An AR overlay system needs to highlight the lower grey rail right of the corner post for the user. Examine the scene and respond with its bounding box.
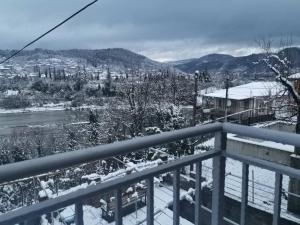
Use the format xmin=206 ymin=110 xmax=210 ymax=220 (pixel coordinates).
xmin=224 ymin=152 xmax=300 ymax=180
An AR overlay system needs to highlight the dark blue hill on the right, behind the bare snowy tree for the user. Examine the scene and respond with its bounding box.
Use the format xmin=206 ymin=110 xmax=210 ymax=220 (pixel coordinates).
xmin=170 ymin=48 xmax=300 ymax=77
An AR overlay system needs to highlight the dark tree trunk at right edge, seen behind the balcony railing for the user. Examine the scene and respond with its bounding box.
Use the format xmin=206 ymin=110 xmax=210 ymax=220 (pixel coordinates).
xmin=288 ymin=106 xmax=300 ymax=215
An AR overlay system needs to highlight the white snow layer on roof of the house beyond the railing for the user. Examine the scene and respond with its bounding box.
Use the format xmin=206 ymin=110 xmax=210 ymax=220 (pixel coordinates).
xmin=204 ymin=81 xmax=283 ymax=100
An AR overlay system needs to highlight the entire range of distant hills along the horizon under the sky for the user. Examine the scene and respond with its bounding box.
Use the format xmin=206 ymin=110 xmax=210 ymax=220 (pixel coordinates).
xmin=0 ymin=48 xmax=300 ymax=78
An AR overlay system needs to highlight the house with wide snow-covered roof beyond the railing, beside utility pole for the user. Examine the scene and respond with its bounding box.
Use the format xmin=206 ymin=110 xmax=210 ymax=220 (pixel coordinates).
xmin=203 ymin=81 xmax=284 ymax=123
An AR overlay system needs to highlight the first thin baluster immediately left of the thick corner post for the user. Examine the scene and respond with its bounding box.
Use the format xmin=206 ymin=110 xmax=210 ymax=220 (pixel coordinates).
xmin=195 ymin=162 xmax=203 ymax=225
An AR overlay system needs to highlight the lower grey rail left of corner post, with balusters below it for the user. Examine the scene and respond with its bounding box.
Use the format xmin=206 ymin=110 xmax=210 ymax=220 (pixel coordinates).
xmin=0 ymin=150 xmax=221 ymax=225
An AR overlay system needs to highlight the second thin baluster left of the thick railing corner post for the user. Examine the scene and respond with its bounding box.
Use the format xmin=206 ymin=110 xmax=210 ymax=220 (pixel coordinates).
xmin=173 ymin=169 xmax=180 ymax=225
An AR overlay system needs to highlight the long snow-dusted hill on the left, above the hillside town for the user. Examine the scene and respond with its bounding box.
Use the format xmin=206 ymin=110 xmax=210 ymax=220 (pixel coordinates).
xmin=0 ymin=48 xmax=164 ymax=69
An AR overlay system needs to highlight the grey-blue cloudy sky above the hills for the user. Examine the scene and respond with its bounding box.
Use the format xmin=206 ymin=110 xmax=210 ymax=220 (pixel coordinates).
xmin=0 ymin=0 xmax=300 ymax=61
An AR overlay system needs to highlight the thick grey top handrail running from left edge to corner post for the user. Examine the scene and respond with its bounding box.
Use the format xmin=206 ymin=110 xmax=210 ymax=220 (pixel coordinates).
xmin=0 ymin=123 xmax=222 ymax=183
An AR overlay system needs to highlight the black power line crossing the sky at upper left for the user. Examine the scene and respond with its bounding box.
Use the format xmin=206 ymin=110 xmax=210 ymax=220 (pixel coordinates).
xmin=0 ymin=0 xmax=98 ymax=65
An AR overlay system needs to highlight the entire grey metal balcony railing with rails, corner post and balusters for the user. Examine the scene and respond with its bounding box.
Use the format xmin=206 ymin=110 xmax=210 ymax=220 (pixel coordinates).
xmin=0 ymin=123 xmax=300 ymax=225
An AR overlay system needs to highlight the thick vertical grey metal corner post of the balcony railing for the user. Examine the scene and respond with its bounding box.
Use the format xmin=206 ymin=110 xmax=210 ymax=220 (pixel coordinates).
xmin=211 ymin=131 xmax=227 ymax=225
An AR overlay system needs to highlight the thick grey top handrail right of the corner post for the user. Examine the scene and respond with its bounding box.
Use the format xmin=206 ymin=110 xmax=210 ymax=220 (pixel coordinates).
xmin=223 ymin=123 xmax=300 ymax=147
